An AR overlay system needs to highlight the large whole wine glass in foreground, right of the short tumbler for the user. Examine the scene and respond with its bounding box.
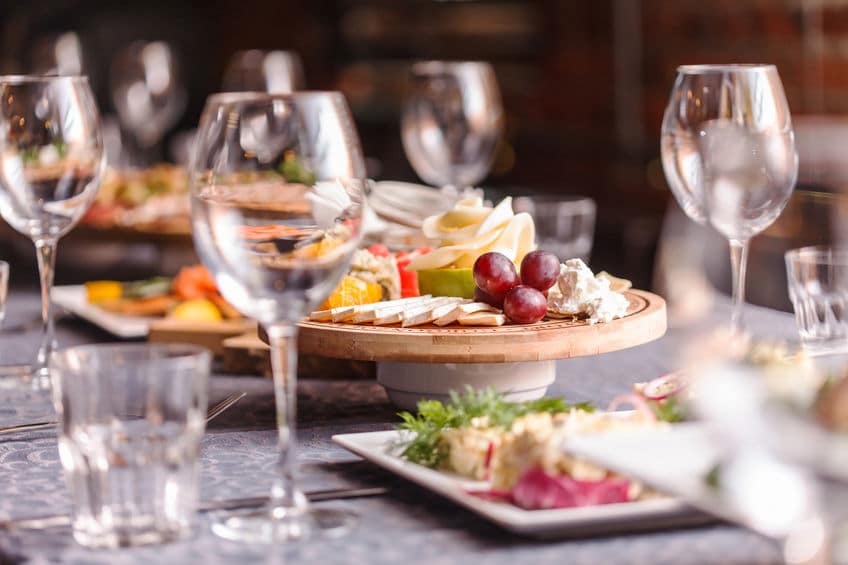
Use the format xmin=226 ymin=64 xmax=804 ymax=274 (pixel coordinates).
xmin=190 ymin=92 xmax=366 ymax=542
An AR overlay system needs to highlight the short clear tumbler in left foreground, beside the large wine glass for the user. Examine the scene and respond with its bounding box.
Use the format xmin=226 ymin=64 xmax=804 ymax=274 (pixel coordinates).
xmin=50 ymin=344 xmax=211 ymax=548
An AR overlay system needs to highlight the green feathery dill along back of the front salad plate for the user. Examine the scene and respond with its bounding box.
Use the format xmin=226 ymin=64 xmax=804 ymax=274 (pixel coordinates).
xmin=398 ymin=388 xmax=594 ymax=468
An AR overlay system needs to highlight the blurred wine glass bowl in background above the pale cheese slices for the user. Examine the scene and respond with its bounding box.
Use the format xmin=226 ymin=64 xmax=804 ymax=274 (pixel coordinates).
xmin=401 ymin=61 xmax=503 ymax=189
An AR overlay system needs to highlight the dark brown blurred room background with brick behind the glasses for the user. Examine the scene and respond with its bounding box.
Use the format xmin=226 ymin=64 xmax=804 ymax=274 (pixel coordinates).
xmin=0 ymin=0 xmax=848 ymax=304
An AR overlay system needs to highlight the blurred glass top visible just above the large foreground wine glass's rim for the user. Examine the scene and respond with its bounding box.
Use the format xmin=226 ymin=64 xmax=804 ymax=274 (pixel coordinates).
xmin=224 ymin=49 xmax=305 ymax=94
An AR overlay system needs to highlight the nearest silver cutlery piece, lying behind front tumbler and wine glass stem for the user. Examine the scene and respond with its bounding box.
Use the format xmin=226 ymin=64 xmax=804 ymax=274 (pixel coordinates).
xmin=0 ymin=487 xmax=389 ymax=530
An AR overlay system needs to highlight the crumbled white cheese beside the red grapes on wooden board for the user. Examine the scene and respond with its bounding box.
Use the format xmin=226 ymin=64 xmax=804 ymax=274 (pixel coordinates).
xmin=548 ymin=259 xmax=628 ymax=324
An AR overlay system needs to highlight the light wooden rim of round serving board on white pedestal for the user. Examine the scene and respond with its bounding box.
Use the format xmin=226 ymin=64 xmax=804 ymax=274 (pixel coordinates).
xmin=298 ymin=290 xmax=666 ymax=363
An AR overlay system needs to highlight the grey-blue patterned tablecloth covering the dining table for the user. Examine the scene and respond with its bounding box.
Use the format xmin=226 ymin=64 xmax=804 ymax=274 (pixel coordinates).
xmin=0 ymin=291 xmax=796 ymax=565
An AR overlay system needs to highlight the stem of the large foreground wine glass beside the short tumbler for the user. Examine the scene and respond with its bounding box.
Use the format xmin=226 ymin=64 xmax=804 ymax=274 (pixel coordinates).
xmin=267 ymin=323 xmax=302 ymax=519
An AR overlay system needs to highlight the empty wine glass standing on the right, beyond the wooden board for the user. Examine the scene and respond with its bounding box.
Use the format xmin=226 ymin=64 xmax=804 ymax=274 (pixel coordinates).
xmin=661 ymin=65 xmax=798 ymax=334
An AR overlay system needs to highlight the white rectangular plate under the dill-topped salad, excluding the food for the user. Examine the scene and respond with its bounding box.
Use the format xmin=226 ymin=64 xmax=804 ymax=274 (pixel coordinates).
xmin=333 ymin=431 xmax=712 ymax=538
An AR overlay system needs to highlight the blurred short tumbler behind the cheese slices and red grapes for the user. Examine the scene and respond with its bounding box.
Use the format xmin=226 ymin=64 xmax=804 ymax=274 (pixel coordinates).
xmin=512 ymin=195 xmax=597 ymax=262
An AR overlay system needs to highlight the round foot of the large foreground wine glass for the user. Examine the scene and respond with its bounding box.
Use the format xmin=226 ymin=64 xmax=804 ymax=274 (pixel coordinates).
xmin=212 ymin=508 xmax=359 ymax=544
